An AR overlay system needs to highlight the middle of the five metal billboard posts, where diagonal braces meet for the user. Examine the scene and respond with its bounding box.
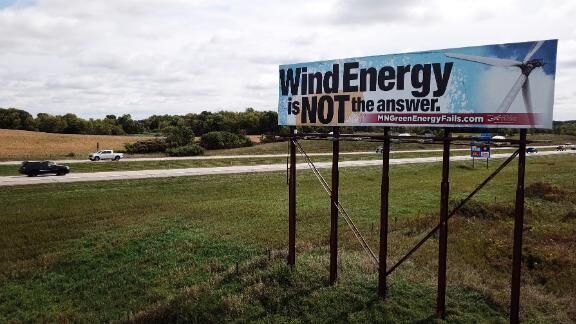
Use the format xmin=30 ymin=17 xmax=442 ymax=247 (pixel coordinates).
xmin=378 ymin=127 xmax=390 ymax=298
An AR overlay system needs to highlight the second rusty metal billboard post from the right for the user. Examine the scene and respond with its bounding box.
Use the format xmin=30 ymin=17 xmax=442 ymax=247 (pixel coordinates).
xmin=436 ymin=128 xmax=450 ymax=318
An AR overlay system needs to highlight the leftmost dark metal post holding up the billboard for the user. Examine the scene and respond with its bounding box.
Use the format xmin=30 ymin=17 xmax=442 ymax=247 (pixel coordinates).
xmin=288 ymin=126 xmax=296 ymax=267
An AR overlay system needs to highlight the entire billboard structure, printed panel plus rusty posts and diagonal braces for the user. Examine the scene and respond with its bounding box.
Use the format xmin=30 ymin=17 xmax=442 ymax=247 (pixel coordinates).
xmin=278 ymin=39 xmax=558 ymax=323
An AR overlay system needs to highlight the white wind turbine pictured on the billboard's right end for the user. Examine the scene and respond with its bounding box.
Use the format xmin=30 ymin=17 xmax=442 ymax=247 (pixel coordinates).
xmin=445 ymin=41 xmax=544 ymax=126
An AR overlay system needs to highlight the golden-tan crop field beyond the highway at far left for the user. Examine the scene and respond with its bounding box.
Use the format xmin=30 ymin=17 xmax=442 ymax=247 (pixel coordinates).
xmin=0 ymin=129 xmax=153 ymax=161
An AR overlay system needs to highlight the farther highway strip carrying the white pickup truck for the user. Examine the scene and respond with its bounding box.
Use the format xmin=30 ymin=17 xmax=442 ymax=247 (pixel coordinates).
xmin=0 ymin=146 xmax=556 ymax=165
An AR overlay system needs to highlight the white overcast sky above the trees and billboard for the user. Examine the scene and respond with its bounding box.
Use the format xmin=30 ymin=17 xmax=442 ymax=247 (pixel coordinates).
xmin=0 ymin=0 xmax=576 ymax=120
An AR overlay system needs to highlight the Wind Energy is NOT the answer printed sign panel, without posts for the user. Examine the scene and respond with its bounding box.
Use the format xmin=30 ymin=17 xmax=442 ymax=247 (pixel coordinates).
xmin=278 ymin=40 xmax=558 ymax=128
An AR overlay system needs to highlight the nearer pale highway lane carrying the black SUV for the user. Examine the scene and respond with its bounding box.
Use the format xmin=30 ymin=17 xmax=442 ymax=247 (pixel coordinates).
xmin=0 ymin=150 xmax=576 ymax=186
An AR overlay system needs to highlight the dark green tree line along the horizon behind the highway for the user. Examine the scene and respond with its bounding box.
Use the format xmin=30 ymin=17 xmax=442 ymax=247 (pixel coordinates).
xmin=0 ymin=108 xmax=576 ymax=136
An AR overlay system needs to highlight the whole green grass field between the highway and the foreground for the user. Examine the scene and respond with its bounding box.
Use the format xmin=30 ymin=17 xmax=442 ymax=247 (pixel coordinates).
xmin=0 ymin=156 xmax=576 ymax=323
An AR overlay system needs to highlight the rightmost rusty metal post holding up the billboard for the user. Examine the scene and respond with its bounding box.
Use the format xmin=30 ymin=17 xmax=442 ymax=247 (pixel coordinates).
xmin=510 ymin=129 xmax=526 ymax=323
